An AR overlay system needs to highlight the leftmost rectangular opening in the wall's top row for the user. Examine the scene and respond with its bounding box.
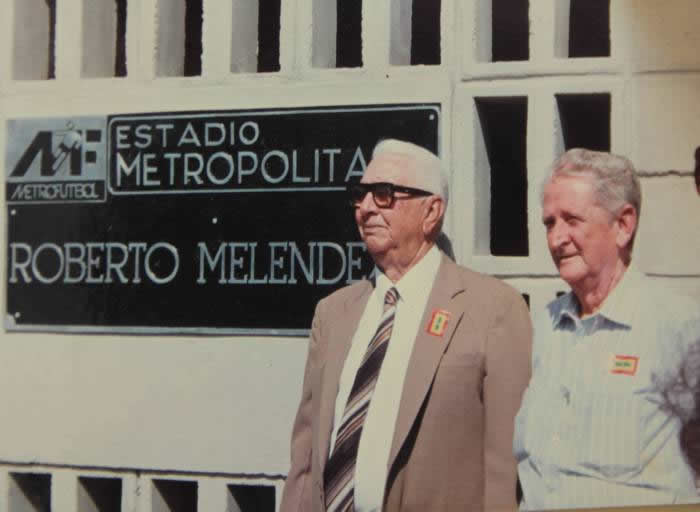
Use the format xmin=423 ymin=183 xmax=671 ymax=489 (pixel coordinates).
xmin=12 ymin=0 xmax=56 ymax=80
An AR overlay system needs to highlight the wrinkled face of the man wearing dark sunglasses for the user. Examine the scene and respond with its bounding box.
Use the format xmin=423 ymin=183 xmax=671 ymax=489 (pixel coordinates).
xmin=355 ymin=153 xmax=432 ymax=263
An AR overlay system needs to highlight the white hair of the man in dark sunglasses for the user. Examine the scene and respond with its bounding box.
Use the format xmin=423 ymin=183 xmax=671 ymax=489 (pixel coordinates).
xmin=372 ymin=139 xmax=450 ymax=205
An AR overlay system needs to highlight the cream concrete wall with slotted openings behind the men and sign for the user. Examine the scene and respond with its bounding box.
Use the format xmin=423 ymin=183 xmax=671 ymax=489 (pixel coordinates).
xmin=0 ymin=0 xmax=700 ymax=512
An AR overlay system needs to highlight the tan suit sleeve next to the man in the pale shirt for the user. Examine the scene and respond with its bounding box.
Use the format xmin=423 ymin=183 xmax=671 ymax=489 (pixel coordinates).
xmin=483 ymin=294 xmax=532 ymax=512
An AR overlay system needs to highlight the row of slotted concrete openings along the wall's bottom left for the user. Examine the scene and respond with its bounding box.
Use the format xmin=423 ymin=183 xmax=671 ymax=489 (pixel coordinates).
xmin=0 ymin=464 xmax=284 ymax=512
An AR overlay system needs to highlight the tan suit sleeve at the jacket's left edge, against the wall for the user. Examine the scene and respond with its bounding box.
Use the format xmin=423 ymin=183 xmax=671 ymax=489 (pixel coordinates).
xmin=280 ymin=303 xmax=321 ymax=512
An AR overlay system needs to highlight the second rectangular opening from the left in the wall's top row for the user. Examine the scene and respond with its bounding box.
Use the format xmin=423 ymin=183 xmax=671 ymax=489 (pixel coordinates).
xmin=81 ymin=0 xmax=127 ymax=78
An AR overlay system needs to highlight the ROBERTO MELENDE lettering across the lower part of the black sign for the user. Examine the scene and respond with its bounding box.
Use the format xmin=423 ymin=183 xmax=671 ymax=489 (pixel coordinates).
xmin=9 ymin=241 xmax=371 ymax=286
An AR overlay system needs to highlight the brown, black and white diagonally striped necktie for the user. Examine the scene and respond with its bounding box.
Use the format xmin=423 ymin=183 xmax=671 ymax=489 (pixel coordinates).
xmin=323 ymin=287 xmax=399 ymax=512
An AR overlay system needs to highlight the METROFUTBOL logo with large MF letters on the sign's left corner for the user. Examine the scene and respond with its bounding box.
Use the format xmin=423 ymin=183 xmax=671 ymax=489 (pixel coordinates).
xmin=6 ymin=118 xmax=106 ymax=203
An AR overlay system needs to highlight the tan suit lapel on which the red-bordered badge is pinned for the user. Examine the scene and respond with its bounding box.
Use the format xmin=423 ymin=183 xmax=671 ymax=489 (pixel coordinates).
xmin=388 ymin=256 xmax=464 ymax=467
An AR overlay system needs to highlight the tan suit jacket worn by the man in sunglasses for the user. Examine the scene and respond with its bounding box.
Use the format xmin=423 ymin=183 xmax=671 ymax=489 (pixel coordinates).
xmin=281 ymin=256 xmax=532 ymax=512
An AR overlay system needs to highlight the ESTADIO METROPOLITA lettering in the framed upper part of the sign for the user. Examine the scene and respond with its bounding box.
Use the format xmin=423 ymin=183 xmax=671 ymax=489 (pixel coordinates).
xmin=110 ymin=120 xmax=378 ymax=193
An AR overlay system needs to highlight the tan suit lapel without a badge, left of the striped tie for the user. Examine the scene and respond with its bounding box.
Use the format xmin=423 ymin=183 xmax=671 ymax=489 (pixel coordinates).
xmin=318 ymin=281 xmax=374 ymax=474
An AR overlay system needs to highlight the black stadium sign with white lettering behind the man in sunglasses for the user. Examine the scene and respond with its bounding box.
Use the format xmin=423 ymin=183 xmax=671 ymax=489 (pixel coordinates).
xmin=6 ymin=105 xmax=440 ymax=334
